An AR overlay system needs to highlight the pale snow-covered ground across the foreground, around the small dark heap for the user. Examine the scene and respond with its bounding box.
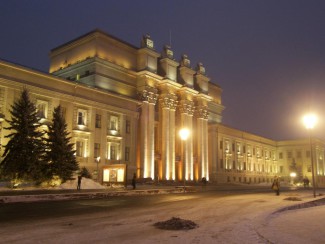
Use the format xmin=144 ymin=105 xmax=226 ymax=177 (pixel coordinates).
xmin=0 ymin=183 xmax=325 ymax=244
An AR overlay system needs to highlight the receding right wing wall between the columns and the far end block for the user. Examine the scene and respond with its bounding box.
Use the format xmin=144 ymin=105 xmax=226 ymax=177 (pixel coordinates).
xmin=209 ymin=124 xmax=285 ymax=183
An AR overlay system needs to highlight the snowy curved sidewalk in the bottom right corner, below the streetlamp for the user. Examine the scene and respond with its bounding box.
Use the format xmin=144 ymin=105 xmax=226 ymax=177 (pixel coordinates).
xmin=256 ymin=191 xmax=325 ymax=244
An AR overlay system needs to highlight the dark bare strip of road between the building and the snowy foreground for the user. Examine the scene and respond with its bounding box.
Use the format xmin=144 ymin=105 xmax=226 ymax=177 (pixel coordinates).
xmin=0 ymin=187 xmax=269 ymax=224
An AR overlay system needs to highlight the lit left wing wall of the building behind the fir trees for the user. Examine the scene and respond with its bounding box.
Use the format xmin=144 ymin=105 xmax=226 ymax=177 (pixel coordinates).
xmin=0 ymin=61 xmax=139 ymax=180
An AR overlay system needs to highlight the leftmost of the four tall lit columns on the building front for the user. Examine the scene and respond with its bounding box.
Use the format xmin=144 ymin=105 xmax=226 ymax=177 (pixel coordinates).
xmin=140 ymin=86 xmax=158 ymax=179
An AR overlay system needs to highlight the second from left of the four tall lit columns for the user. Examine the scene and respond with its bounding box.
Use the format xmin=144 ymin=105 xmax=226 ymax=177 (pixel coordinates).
xmin=159 ymin=94 xmax=177 ymax=180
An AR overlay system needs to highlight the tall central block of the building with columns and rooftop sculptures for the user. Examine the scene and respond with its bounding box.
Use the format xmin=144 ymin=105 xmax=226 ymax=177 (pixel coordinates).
xmin=50 ymin=30 xmax=223 ymax=180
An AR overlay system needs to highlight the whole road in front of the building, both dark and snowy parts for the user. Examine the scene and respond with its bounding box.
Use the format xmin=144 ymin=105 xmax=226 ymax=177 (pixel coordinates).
xmin=0 ymin=188 xmax=322 ymax=244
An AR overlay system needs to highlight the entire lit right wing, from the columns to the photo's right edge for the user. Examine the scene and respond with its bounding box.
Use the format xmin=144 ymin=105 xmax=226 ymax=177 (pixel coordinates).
xmin=209 ymin=124 xmax=325 ymax=186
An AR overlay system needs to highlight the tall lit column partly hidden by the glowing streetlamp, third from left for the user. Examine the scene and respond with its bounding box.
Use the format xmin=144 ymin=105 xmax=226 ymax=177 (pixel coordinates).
xmin=179 ymin=100 xmax=194 ymax=180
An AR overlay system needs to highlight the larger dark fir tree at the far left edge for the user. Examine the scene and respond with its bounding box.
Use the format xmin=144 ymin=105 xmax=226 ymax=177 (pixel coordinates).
xmin=0 ymin=89 xmax=46 ymax=183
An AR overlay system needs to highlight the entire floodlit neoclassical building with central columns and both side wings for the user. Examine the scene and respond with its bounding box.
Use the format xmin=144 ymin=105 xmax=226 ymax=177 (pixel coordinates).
xmin=0 ymin=30 xmax=325 ymax=187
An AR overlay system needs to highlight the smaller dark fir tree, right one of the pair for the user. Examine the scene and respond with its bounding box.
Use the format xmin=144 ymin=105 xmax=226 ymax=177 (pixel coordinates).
xmin=47 ymin=106 xmax=79 ymax=182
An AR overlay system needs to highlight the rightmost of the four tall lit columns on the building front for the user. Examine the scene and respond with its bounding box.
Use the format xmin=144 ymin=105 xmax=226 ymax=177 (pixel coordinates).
xmin=196 ymin=105 xmax=209 ymax=180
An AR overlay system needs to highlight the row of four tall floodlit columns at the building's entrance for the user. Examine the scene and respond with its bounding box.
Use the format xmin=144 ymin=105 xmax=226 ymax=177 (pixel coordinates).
xmin=140 ymin=84 xmax=209 ymax=180
